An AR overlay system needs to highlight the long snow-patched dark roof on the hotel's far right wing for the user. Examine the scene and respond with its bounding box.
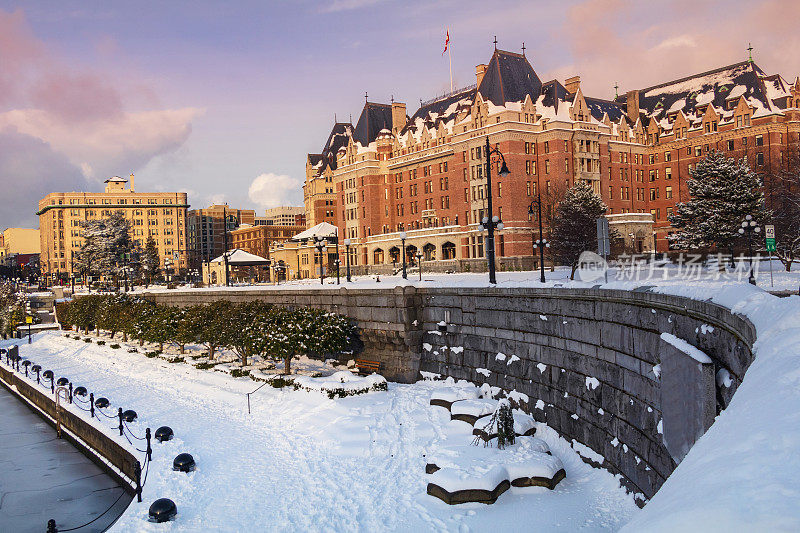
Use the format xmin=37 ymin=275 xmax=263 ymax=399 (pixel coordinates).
xmin=639 ymin=61 xmax=769 ymax=117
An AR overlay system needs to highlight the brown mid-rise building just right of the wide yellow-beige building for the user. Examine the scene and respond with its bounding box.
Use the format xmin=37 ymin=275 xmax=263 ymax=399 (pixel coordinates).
xmin=186 ymin=204 xmax=256 ymax=268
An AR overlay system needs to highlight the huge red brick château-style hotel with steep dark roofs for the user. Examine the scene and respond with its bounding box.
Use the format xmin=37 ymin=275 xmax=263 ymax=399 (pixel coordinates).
xmin=304 ymin=50 xmax=800 ymax=268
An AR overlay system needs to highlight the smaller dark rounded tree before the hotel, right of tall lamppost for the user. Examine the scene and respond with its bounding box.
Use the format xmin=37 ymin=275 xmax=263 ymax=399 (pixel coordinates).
xmin=550 ymin=182 xmax=607 ymax=279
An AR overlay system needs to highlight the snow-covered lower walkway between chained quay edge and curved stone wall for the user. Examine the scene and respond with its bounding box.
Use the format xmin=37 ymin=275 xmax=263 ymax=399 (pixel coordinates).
xmin=2 ymin=332 xmax=638 ymax=531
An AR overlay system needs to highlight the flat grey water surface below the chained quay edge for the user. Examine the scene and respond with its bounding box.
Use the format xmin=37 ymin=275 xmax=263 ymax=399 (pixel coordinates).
xmin=0 ymin=385 xmax=131 ymax=533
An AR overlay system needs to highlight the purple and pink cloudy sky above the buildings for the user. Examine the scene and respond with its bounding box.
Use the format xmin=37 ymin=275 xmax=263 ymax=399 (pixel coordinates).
xmin=0 ymin=0 xmax=800 ymax=229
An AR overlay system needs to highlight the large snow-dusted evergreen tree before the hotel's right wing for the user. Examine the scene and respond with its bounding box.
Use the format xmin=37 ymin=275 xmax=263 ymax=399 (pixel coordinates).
xmin=669 ymin=150 xmax=768 ymax=253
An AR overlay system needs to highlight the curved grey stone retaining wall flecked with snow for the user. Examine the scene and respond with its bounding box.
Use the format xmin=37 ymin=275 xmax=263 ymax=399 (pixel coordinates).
xmin=145 ymin=287 xmax=755 ymax=498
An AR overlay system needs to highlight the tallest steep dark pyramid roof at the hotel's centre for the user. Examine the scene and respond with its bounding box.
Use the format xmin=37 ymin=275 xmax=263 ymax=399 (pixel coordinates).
xmin=478 ymin=50 xmax=542 ymax=106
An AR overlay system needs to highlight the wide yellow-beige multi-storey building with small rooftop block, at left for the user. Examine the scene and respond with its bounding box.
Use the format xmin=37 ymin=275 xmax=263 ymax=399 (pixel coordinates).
xmin=36 ymin=174 xmax=189 ymax=274
